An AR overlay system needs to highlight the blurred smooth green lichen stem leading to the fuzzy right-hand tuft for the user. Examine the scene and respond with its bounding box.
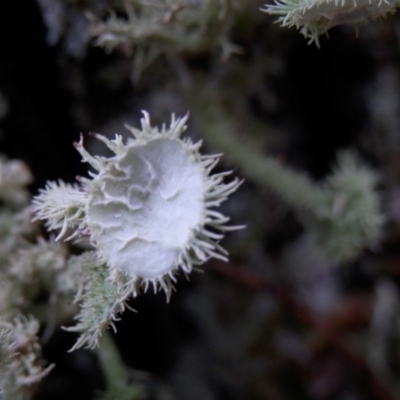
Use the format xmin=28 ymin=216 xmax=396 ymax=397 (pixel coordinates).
xmin=188 ymin=91 xmax=327 ymax=211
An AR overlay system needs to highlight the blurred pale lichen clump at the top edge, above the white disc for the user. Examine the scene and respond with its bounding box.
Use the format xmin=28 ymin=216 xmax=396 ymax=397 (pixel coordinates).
xmin=87 ymin=0 xmax=240 ymax=78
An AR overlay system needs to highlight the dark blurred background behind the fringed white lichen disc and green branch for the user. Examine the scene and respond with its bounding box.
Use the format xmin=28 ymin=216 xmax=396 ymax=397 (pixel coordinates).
xmin=0 ymin=0 xmax=400 ymax=400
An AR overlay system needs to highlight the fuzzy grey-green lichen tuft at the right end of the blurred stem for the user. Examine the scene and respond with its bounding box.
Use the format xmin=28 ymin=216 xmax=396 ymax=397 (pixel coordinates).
xmin=310 ymin=151 xmax=385 ymax=261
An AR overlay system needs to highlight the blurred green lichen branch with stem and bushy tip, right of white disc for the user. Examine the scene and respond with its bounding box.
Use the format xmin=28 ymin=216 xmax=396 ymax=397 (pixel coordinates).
xmin=186 ymin=82 xmax=385 ymax=262
